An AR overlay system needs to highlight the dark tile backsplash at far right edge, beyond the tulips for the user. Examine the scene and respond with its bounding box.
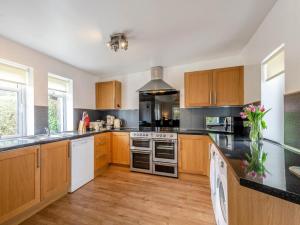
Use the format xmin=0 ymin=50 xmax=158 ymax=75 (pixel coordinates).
xmin=284 ymin=92 xmax=300 ymax=149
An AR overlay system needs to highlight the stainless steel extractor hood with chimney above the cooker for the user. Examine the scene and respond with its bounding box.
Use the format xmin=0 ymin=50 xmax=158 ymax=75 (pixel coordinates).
xmin=137 ymin=66 xmax=176 ymax=94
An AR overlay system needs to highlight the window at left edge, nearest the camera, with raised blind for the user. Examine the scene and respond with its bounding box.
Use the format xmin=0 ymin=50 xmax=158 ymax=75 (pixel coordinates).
xmin=0 ymin=60 xmax=30 ymax=137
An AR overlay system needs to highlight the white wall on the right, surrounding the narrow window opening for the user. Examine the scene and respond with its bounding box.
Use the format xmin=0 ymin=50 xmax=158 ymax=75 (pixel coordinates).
xmin=242 ymin=0 xmax=300 ymax=103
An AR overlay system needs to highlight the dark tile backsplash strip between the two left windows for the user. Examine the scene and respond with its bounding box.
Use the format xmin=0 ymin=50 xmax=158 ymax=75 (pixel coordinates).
xmin=34 ymin=105 xmax=48 ymax=134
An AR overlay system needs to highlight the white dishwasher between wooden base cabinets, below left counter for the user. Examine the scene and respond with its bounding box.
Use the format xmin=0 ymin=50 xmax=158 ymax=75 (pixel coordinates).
xmin=69 ymin=136 xmax=94 ymax=192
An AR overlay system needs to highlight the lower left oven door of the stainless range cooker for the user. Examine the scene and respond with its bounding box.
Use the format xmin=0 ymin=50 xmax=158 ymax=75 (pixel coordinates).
xmin=130 ymin=150 xmax=152 ymax=173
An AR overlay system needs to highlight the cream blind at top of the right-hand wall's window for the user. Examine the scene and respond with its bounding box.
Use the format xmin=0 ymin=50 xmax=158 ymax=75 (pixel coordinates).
xmin=262 ymin=45 xmax=285 ymax=80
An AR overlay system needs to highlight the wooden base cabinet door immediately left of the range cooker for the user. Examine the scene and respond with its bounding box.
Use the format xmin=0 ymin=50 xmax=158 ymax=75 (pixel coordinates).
xmin=112 ymin=132 xmax=130 ymax=165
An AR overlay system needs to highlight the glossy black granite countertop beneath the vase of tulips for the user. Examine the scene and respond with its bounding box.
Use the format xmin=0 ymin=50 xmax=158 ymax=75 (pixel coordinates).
xmin=209 ymin=133 xmax=300 ymax=204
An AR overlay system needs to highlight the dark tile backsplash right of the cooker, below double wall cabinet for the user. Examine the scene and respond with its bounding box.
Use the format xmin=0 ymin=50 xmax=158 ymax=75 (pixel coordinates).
xmin=180 ymin=107 xmax=242 ymax=129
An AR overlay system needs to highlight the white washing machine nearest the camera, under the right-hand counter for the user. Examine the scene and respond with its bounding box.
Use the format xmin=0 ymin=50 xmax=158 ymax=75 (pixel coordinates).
xmin=215 ymin=153 xmax=228 ymax=225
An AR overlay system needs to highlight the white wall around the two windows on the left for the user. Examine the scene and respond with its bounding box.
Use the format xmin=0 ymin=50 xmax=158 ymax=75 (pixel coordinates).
xmin=0 ymin=37 xmax=96 ymax=109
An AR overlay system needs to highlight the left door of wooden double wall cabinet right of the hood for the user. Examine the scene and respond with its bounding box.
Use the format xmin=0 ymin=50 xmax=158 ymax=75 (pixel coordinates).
xmin=184 ymin=70 xmax=212 ymax=107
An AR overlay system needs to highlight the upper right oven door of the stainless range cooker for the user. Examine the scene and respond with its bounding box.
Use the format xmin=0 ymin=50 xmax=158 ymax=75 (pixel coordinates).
xmin=153 ymin=140 xmax=177 ymax=163
